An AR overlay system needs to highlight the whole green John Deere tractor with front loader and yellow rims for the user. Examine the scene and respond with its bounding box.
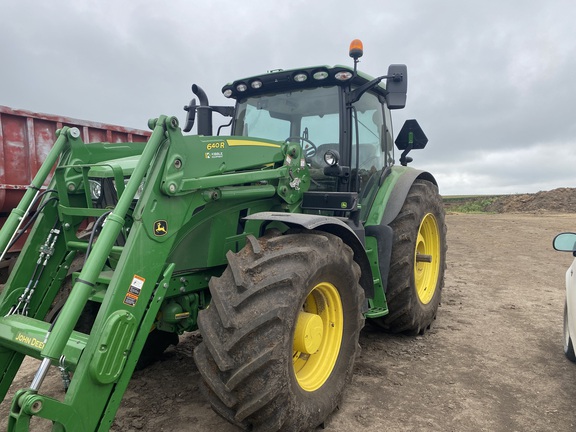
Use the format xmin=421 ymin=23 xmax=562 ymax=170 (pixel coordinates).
xmin=0 ymin=41 xmax=446 ymax=432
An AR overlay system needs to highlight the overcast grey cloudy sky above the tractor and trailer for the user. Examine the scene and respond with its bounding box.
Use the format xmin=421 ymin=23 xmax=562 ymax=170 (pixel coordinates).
xmin=0 ymin=0 xmax=576 ymax=195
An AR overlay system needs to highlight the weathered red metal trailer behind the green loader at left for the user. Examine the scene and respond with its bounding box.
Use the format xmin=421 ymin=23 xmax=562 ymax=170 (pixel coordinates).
xmin=0 ymin=105 xmax=150 ymax=282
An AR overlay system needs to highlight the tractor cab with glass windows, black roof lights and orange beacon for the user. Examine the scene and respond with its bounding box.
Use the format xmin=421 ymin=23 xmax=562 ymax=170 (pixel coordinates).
xmin=184 ymin=40 xmax=425 ymax=220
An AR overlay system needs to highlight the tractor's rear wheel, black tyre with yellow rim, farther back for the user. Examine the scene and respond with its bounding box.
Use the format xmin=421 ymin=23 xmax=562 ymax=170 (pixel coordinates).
xmin=371 ymin=180 xmax=446 ymax=334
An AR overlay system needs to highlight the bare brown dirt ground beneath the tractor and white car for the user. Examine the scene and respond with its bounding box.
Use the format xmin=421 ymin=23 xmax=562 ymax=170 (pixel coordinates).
xmin=0 ymin=212 xmax=576 ymax=432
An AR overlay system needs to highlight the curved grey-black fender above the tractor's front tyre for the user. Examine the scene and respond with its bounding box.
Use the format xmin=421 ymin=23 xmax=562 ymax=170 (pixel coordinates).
xmin=244 ymin=212 xmax=374 ymax=298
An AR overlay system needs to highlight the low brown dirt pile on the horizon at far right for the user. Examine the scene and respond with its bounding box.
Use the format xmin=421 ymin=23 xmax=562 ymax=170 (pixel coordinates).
xmin=486 ymin=188 xmax=576 ymax=213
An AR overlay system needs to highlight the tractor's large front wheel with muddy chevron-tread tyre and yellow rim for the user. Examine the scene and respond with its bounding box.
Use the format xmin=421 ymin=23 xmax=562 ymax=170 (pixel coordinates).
xmin=194 ymin=231 xmax=364 ymax=431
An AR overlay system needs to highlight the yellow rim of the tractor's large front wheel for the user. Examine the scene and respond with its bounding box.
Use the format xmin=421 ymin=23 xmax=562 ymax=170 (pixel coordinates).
xmin=292 ymin=282 xmax=344 ymax=392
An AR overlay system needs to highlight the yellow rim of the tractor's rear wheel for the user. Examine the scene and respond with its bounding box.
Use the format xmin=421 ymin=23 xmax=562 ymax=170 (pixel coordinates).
xmin=414 ymin=213 xmax=440 ymax=304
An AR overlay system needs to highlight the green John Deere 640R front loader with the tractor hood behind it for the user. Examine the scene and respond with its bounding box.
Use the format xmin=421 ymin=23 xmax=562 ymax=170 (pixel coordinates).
xmin=0 ymin=116 xmax=309 ymax=432
